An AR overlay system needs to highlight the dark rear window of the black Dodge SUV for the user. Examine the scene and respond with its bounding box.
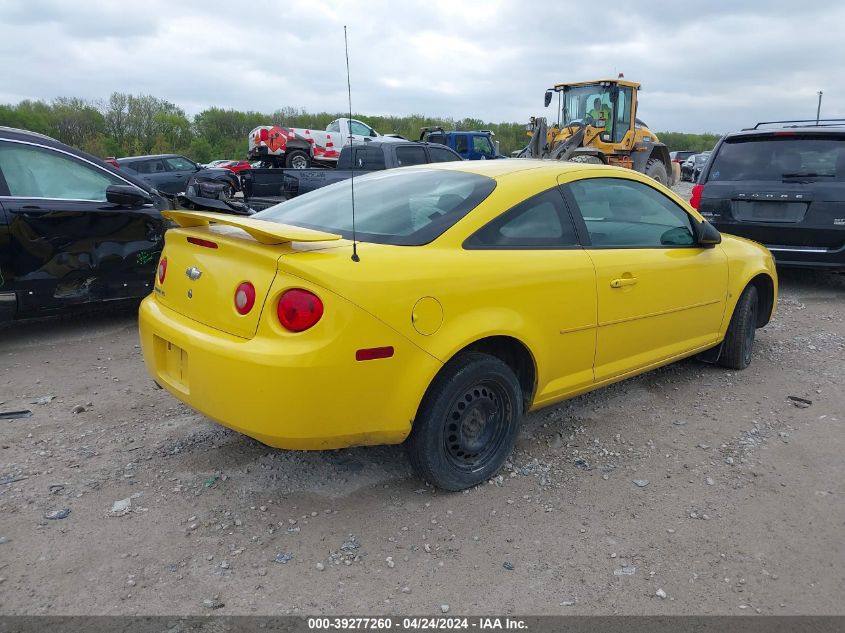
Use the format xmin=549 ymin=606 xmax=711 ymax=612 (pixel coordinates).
xmin=708 ymin=135 xmax=845 ymax=181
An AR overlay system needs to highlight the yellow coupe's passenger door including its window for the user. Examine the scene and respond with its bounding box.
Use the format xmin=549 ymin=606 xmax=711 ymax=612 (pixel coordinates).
xmin=568 ymin=178 xmax=728 ymax=382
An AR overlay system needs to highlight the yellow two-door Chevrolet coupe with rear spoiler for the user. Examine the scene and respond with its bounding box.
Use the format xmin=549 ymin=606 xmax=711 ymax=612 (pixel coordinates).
xmin=140 ymin=160 xmax=777 ymax=490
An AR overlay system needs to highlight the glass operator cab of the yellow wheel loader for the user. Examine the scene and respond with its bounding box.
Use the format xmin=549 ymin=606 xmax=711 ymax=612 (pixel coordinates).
xmin=545 ymin=81 xmax=639 ymax=144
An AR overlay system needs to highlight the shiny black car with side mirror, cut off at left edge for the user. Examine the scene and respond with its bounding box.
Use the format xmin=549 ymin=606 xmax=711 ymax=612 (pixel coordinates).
xmin=0 ymin=127 xmax=172 ymax=322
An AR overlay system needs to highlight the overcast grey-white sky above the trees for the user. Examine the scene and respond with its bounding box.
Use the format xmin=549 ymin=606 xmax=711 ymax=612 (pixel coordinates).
xmin=0 ymin=0 xmax=845 ymax=133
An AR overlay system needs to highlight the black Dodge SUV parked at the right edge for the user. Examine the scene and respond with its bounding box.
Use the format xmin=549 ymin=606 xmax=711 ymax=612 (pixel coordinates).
xmin=690 ymin=119 xmax=845 ymax=269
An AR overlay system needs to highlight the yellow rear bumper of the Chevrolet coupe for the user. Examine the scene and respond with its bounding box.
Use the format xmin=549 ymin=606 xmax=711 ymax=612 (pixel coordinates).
xmin=139 ymin=296 xmax=441 ymax=450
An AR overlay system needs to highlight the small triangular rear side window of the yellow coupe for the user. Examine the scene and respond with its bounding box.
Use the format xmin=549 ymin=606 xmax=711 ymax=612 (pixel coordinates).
xmin=464 ymin=187 xmax=578 ymax=249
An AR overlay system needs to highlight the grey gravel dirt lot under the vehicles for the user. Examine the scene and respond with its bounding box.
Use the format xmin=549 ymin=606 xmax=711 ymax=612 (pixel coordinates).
xmin=0 ymin=189 xmax=845 ymax=614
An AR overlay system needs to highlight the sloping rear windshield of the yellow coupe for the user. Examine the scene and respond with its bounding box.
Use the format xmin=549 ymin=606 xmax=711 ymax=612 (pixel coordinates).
xmin=252 ymin=169 xmax=496 ymax=246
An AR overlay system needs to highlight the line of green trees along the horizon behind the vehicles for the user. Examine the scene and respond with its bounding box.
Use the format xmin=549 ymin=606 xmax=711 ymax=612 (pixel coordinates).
xmin=0 ymin=92 xmax=719 ymax=163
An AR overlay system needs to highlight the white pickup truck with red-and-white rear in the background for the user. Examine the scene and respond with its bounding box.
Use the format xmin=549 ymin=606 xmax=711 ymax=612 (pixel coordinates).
xmin=249 ymin=119 xmax=405 ymax=169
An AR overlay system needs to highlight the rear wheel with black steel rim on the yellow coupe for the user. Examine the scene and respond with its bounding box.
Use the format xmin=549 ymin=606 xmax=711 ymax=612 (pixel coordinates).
xmin=405 ymin=352 xmax=523 ymax=491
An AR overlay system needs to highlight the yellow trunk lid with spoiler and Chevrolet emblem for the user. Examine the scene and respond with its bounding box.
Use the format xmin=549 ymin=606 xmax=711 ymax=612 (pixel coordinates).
xmin=155 ymin=211 xmax=339 ymax=338
